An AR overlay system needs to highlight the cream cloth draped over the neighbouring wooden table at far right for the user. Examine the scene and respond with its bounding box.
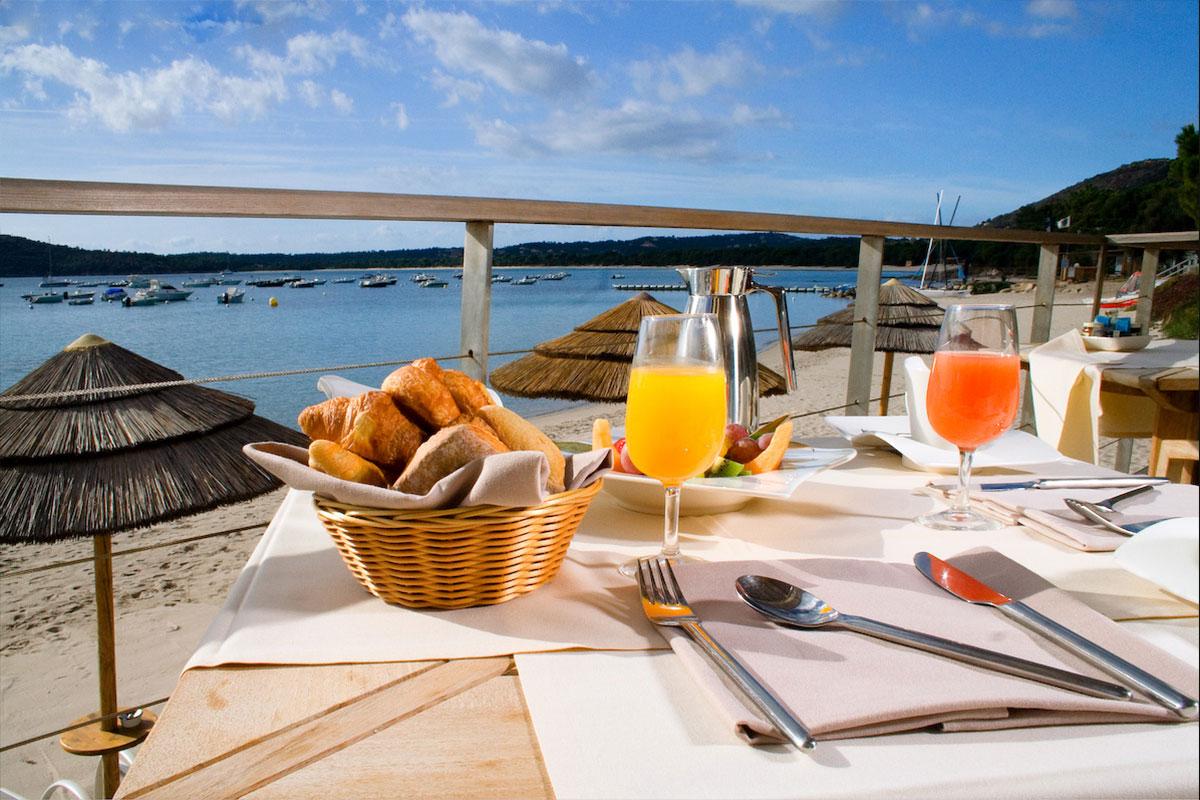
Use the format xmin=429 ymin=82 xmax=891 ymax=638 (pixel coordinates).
xmin=1030 ymin=330 xmax=1198 ymax=464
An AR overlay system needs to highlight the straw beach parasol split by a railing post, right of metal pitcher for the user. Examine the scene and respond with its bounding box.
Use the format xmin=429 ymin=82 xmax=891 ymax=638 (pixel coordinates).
xmin=792 ymin=278 xmax=946 ymax=414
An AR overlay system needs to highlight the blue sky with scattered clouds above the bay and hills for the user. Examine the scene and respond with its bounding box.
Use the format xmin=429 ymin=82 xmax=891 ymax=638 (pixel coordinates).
xmin=0 ymin=0 xmax=1200 ymax=253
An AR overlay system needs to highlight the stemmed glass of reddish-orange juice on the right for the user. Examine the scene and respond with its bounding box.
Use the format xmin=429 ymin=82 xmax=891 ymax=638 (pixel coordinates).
xmin=917 ymin=305 xmax=1021 ymax=530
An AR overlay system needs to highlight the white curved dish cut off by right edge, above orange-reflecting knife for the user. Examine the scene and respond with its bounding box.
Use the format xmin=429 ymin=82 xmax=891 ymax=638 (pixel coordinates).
xmin=1112 ymin=517 xmax=1200 ymax=603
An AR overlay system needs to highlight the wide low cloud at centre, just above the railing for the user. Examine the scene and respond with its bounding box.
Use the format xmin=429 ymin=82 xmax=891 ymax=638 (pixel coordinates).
xmin=472 ymin=101 xmax=730 ymax=160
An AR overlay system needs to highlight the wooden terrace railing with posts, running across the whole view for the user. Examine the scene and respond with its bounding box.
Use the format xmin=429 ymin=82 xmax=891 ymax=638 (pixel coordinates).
xmin=0 ymin=178 xmax=1198 ymax=414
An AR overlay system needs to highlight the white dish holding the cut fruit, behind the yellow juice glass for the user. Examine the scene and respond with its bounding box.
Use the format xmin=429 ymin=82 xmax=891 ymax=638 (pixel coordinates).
xmin=604 ymin=447 xmax=856 ymax=516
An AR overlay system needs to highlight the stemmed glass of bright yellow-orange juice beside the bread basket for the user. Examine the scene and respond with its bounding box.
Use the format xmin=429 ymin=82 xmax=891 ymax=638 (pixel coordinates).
xmin=620 ymin=314 xmax=725 ymax=577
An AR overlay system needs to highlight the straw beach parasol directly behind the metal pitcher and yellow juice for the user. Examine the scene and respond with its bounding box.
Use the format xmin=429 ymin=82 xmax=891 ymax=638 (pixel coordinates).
xmin=491 ymin=291 xmax=786 ymax=403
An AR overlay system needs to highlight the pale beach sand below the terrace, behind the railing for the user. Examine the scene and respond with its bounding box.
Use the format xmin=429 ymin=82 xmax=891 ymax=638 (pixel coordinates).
xmin=0 ymin=284 xmax=1132 ymax=798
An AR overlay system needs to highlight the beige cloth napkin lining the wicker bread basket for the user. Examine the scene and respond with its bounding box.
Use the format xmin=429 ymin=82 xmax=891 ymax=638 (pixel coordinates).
xmin=242 ymin=441 xmax=612 ymax=510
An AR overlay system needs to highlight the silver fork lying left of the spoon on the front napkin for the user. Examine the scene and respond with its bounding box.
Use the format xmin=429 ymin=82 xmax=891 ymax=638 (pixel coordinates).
xmin=637 ymin=555 xmax=816 ymax=750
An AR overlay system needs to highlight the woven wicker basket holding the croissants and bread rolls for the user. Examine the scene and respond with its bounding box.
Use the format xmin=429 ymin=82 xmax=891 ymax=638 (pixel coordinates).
xmin=313 ymin=481 xmax=604 ymax=608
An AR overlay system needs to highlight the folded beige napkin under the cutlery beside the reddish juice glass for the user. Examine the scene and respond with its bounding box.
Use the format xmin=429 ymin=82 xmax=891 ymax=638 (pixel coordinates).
xmin=930 ymin=477 xmax=1200 ymax=552
